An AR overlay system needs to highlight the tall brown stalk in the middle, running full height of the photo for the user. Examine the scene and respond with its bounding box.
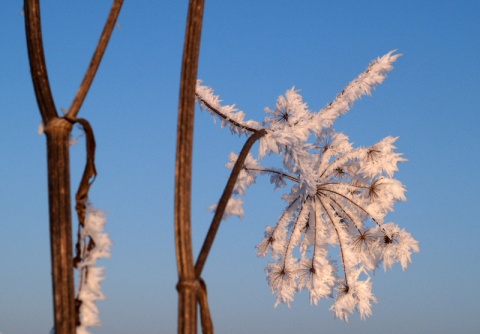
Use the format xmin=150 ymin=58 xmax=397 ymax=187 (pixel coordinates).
xmin=175 ymin=0 xmax=204 ymax=334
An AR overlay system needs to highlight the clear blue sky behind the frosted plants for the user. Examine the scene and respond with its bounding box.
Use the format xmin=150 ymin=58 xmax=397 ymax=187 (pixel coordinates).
xmin=0 ymin=0 xmax=480 ymax=334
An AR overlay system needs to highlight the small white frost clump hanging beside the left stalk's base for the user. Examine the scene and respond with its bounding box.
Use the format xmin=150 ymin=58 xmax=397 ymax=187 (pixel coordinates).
xmin=77 ymin=205 xmax=112 ymax=334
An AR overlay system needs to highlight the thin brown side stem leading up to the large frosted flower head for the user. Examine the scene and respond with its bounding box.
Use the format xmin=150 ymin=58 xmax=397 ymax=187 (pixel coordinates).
xmin=195 ymin=129 xmax=267 ymax=277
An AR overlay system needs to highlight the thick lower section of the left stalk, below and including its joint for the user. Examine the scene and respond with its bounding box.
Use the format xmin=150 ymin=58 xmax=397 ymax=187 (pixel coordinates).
xmin=45 ymin=118 xmax=76 ymax=334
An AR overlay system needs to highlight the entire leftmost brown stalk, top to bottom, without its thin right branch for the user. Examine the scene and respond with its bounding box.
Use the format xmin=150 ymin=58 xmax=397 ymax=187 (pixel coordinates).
xmin=24 ymin=0 xmax=76 ymax=334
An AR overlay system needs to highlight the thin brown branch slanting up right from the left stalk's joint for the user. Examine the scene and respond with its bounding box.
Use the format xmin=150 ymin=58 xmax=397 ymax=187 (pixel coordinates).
xmin=68 ymin=0 xmax=123 ymax=117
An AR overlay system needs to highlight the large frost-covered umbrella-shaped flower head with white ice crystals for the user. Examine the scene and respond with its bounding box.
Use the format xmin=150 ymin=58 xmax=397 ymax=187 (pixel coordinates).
xmin=196 ymin=51 xmax=419 ymax=320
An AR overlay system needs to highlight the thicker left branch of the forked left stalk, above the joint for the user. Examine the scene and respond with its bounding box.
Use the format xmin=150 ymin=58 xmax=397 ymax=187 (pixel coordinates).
xmin=23 ymin=0 xmax=57 ymax=124
